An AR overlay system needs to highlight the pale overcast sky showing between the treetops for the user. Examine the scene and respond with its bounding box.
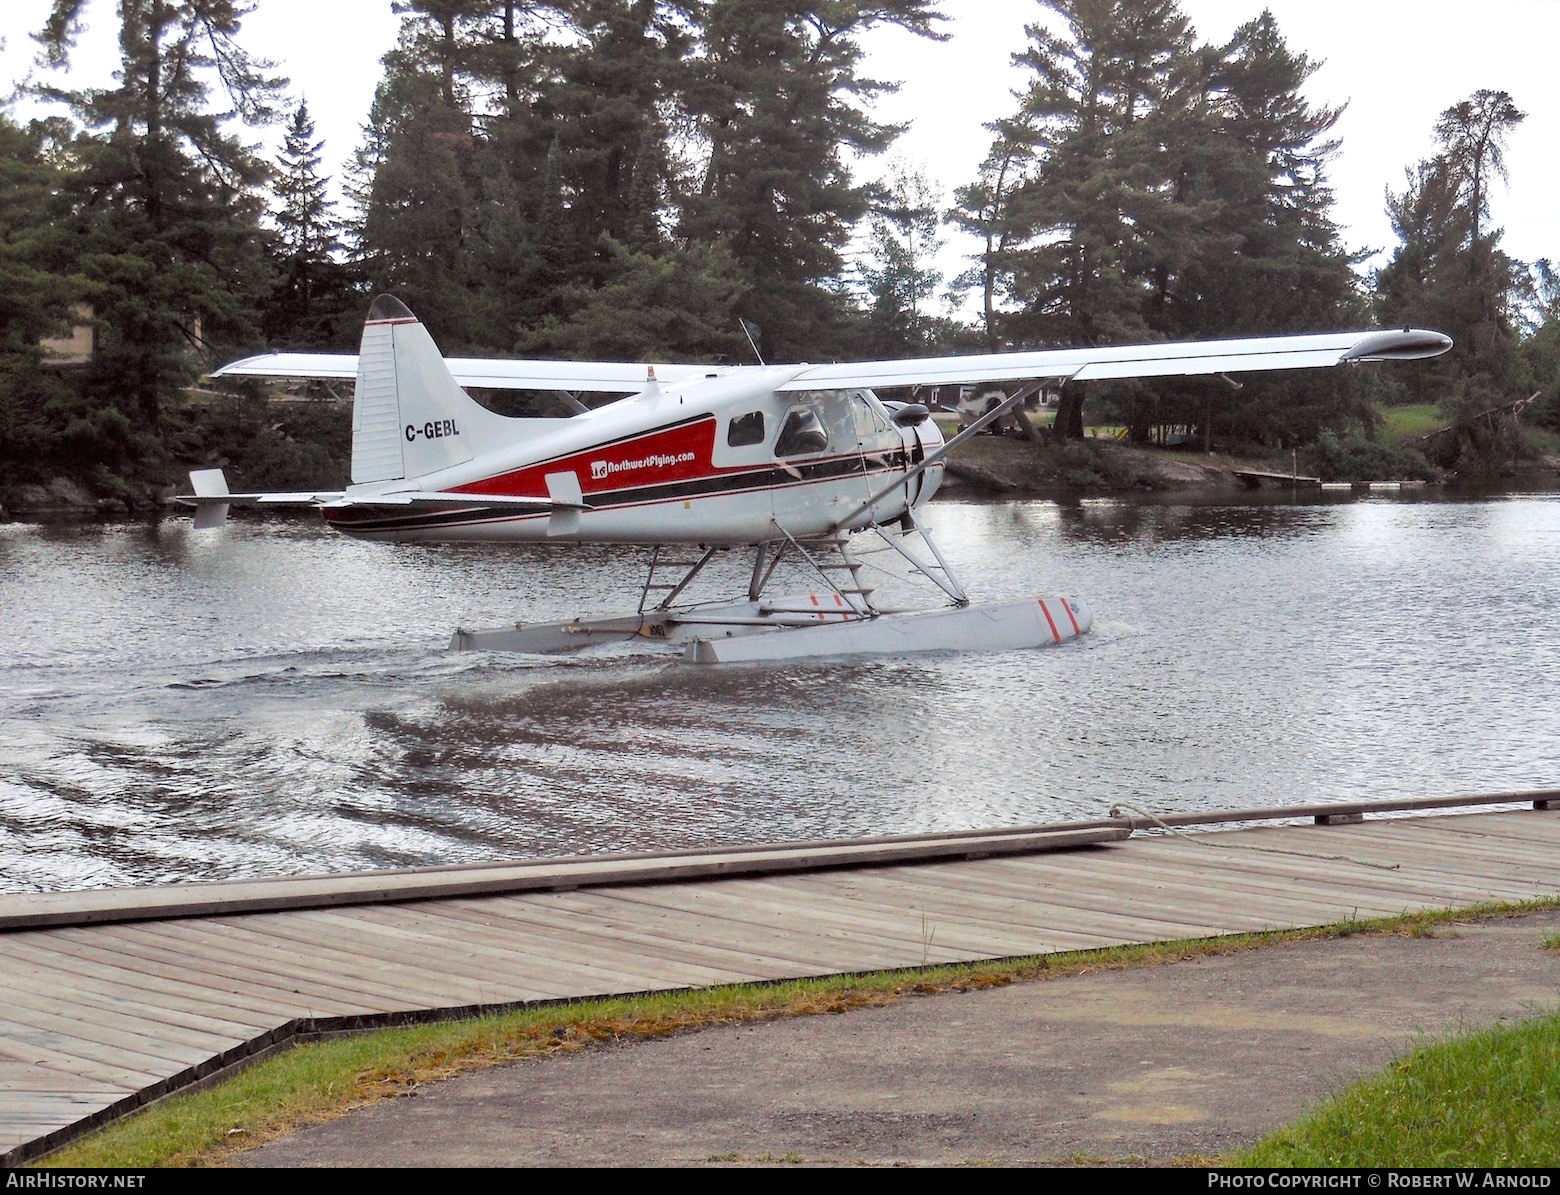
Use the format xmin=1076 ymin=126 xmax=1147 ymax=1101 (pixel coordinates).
xmin=0 ymin=0 xmax=1560 ymax=313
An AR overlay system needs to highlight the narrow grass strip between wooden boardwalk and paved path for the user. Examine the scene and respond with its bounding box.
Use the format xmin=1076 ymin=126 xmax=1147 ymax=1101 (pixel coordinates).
xmin=33 ymin=900 xmax=1560 ymax=1167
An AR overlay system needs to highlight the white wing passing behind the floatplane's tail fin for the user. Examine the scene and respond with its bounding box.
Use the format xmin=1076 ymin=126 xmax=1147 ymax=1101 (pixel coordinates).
xmin=211 ymin=353 xmax=747 ymax=395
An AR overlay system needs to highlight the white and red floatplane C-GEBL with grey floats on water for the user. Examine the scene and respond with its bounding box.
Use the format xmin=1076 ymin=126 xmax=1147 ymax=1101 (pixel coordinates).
xmin=179 ymin=295 xmax=1451 ymax=663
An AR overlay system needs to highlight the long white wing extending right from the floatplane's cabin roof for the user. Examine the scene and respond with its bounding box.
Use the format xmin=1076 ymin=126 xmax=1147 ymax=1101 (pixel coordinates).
xmin=778 ymin=328 xmax=1452 ymax=390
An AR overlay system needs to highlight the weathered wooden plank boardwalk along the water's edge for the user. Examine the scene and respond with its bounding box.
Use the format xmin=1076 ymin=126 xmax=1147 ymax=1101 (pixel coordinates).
xmin=0 ymin=793 xmax=1560 ymax=1164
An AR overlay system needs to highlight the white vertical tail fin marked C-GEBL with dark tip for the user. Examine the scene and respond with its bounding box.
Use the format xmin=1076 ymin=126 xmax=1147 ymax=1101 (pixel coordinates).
xmin=353 ymin=295 xmax=474 ymax=485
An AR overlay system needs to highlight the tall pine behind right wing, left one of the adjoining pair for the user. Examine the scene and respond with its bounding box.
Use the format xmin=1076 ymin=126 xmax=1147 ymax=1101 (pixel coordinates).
xmin=1002 ymin=0 xmax=1198 ymax=437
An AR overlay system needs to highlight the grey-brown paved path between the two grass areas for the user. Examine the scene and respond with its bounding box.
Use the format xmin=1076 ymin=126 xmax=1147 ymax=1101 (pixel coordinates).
xmin=236 ymin=913 xmax=1560 ymax=1165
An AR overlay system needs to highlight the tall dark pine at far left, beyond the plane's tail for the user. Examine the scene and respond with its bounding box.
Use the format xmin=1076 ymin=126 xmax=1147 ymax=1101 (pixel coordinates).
xmin=39 ymin=0 xmax=281 ymax=434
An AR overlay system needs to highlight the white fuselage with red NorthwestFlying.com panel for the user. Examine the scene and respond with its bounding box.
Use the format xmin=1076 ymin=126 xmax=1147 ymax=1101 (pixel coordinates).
xmin=324 ymin=365 xmax=942 ymax=546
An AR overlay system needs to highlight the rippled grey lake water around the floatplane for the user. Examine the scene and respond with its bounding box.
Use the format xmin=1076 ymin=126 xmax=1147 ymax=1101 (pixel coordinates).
xmin=0 ymin=495 xmax=1560 ymax=891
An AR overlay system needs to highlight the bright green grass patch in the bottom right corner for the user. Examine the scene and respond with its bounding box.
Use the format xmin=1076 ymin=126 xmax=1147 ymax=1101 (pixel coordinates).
xmin=1234 ymin=1014 xmax=1560 ymax=1167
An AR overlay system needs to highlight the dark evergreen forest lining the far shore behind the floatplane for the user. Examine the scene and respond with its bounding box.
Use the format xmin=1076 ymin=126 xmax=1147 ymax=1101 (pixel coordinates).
xmin=0 ymin=0 xmax=1560 ymax=510
